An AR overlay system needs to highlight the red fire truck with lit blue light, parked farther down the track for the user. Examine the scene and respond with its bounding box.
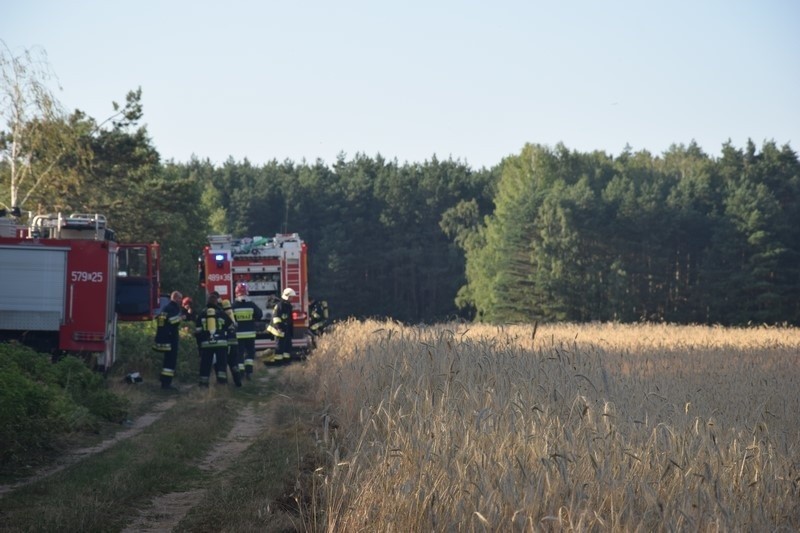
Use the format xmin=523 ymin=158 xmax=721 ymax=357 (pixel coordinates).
xmin=198 ymin=233 xmax=311 ymax=352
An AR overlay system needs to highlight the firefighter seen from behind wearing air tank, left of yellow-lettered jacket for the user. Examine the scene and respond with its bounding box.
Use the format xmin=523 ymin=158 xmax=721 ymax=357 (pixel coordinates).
xmin=197 ymin=291 xmax=232 ymax=387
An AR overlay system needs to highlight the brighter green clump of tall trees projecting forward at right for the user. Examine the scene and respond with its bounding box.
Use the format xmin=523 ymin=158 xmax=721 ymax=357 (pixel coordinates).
xmin=459 ymin=142 xmax=800 ymax=324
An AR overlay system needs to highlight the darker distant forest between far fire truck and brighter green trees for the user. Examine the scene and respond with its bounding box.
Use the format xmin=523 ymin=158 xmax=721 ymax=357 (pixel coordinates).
xmin=167 ymin=155 xmax=497 ymax=322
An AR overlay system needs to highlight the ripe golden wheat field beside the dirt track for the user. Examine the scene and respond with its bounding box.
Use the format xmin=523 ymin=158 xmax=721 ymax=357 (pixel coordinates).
xmin=287 ymin=320 xmax=800 ymax=532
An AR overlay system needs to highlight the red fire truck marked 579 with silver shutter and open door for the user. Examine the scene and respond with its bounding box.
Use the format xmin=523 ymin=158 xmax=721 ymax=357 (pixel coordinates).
xmin=0 ymin=213 xmax=160 ymax=371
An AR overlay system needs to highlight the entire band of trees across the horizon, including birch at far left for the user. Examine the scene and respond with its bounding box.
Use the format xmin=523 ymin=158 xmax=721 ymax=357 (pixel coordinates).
xmin=0 ymin=78 xmax=800 ymax=325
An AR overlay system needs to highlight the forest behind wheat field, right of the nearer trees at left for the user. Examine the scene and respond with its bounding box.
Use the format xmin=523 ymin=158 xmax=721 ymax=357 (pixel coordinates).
xmin=173 ymin=138 xmax=800 ymax=324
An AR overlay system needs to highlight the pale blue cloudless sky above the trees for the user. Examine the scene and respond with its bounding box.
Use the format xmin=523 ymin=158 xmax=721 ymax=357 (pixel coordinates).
xmin=0 ymin=0 xmax=800 ymax=169
